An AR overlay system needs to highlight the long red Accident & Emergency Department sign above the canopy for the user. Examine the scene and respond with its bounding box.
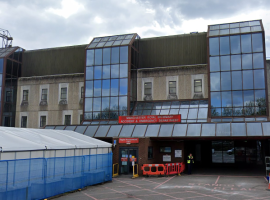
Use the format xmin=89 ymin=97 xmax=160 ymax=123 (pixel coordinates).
xmin=118 ymin=115 xmax=181 ymax=124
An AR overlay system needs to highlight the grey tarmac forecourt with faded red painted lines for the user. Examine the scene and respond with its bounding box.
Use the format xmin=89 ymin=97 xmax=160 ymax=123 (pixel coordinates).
xmin=54 ymin=173 xmax=270 ymax=200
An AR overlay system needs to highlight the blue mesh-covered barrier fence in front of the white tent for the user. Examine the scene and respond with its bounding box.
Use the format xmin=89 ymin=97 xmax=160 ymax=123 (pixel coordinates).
xmin=0 ymin=153 xmax=112 ymax=200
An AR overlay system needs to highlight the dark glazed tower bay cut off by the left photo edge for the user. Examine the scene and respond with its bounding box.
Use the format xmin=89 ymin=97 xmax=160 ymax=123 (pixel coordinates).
xmin=0 ymin=47 xmax=23 ymax=127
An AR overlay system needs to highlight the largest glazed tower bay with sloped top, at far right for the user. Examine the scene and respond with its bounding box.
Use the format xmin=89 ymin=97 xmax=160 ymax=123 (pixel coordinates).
xmin=209 ymin=21 xmax=267 ymax=117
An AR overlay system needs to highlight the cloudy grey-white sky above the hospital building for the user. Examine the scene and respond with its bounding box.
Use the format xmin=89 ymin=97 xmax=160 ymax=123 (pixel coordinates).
xmin=0 ymin=0 xmax=270 ymax=58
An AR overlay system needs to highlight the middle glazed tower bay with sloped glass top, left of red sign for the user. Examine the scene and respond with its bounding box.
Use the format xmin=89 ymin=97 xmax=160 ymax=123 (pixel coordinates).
xmin=84 ymin=35 xmax=137 ymax=120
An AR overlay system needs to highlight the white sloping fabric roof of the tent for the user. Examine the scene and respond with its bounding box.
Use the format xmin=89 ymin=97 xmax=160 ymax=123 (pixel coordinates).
xmin=0 ymin=127 xmax=112 ymax=151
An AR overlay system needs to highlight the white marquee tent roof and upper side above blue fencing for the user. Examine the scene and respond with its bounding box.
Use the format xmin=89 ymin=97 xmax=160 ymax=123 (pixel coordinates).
xmin=0 ymin=127 xmax=112 ymax=160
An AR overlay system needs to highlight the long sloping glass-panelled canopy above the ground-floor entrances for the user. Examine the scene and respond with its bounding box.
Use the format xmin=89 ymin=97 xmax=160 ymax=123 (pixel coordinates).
xmin=45 ymin=122 xmax=270 ymax=138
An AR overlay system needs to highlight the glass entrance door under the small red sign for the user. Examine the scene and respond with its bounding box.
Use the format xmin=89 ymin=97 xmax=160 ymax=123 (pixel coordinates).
xmin=119 ymin=147 xmax=138 ymax=174
